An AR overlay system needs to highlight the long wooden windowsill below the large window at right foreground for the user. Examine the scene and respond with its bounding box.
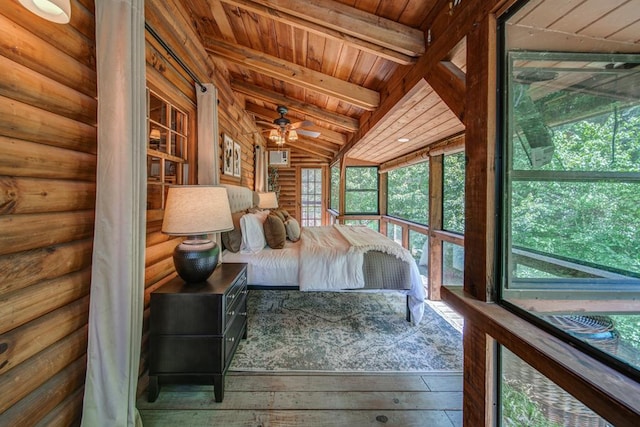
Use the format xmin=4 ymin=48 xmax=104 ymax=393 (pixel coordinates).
xmin=441 ymin=286 xmax=640 ymax=426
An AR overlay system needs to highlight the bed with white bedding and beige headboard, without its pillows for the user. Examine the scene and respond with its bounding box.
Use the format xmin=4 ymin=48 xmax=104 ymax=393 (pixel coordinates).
xmin=222 ymin=185 xmax=425 ymax=324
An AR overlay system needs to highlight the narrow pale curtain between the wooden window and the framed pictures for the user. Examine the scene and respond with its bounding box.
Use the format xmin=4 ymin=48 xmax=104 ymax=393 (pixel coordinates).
xmin=196 ymin=83 xmax=220 ymax=185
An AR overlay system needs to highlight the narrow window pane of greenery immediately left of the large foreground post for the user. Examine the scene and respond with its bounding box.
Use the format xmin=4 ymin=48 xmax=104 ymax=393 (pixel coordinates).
xmin=442 ymin=153 xmax=465 ymax=234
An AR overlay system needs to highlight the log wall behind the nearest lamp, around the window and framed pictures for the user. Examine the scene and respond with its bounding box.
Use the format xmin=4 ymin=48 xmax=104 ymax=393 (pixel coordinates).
xmin=138 ymin=0 xmax=255 ymax=393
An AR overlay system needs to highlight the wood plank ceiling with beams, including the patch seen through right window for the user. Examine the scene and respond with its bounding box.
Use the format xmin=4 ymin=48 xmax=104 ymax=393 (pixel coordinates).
xmin=181 ymin=0 xmax=639 ymax=164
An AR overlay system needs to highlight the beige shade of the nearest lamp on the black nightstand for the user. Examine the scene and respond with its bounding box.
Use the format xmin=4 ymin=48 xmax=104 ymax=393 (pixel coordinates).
xmin=162 ymin=185 xmax=233 ymax=236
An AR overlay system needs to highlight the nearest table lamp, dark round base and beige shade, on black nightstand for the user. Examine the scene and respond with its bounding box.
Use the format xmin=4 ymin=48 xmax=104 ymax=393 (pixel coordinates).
xmin=162 ymin=185 xmax=233 ymax=283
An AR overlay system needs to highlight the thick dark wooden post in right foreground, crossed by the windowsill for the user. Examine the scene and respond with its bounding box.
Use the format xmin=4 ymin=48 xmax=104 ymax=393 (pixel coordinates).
xmin=463 ymin=15 xmax=497 ymax=427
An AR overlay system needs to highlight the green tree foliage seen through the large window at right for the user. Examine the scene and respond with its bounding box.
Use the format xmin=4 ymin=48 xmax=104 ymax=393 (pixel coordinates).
xmin=511 ymin=104 xmax=640 ymax=273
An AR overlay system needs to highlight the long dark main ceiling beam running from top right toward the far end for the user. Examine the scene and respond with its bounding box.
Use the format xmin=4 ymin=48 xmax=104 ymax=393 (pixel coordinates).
xmin=331 ymin=0 xmax=513 ymax=163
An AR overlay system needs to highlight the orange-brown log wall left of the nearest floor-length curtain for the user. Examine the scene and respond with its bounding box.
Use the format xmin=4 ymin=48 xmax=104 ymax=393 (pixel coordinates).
xmin=0 ymin=0 xmax=97 ymax=425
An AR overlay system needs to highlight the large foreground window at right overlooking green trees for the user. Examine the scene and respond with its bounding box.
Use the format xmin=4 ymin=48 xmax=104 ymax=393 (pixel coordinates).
xmin=499 ymin=2 xmax=640 ymax=384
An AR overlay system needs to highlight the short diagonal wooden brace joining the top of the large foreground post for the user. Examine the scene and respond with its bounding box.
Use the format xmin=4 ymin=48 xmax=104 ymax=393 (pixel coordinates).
xmin=427 ymin=61 xmax=467 ymax=121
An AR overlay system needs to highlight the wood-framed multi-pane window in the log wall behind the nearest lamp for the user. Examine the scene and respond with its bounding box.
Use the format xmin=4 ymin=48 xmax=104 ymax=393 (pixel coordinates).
xmin=147 ymin=90 xmax=188 ymax=209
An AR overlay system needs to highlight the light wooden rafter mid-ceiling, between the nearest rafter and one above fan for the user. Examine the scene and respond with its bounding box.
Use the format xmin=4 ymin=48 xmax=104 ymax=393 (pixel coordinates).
xmin=204 ymin=37 xmax=380 ymax=111
